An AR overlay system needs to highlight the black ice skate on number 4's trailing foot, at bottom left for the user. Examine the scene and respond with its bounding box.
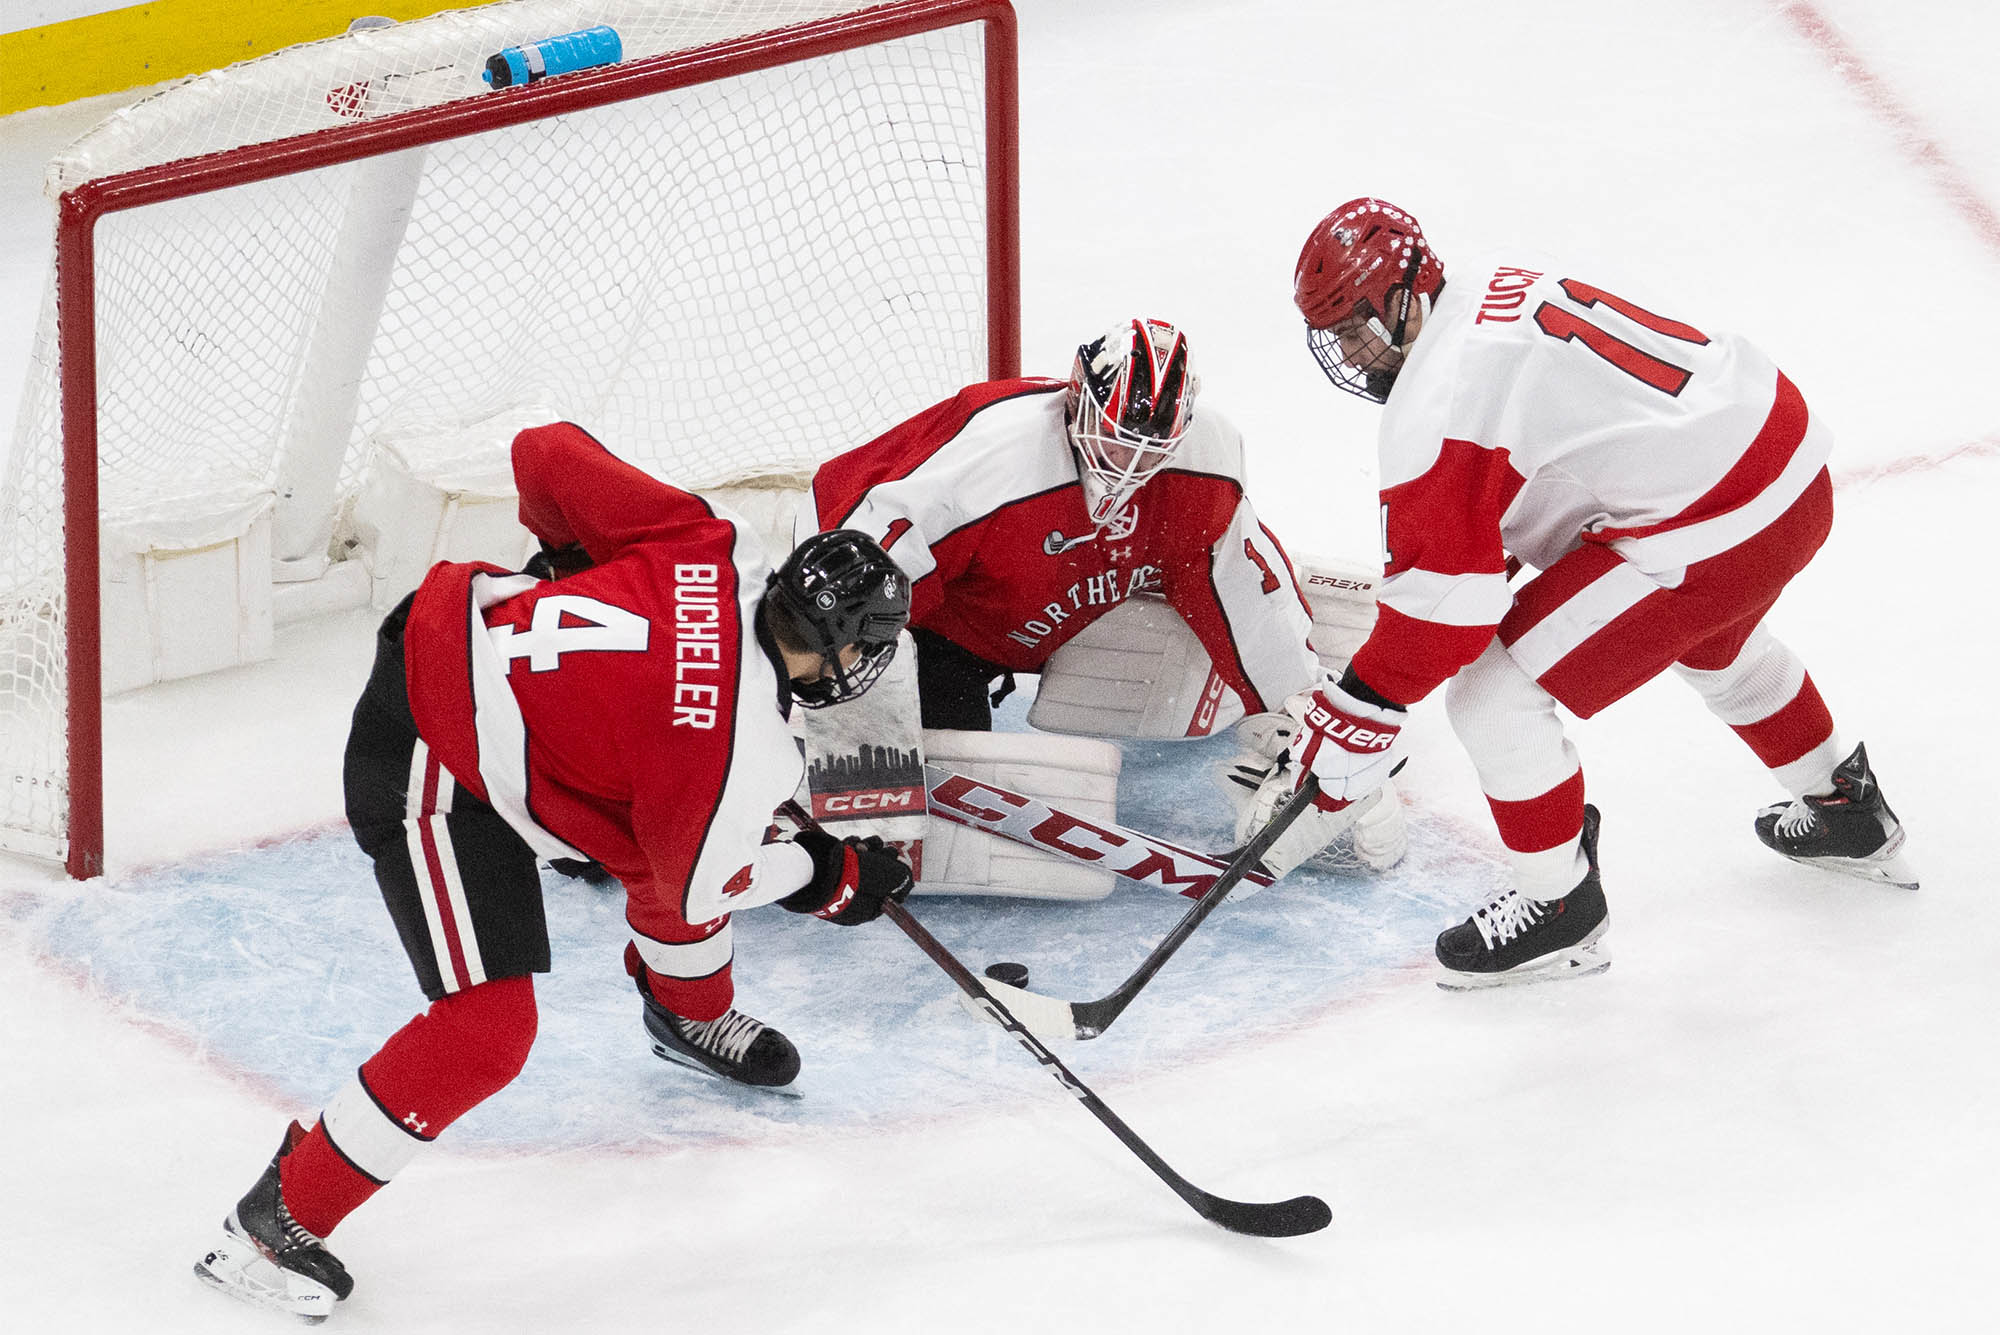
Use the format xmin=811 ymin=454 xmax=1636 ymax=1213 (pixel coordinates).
xmin=194 ymin=1121 xmax=354 ymax=1325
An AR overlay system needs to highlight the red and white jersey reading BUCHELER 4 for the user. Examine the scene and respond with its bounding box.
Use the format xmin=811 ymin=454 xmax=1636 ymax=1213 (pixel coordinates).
xmin=404 ymin=422 xmax=812 ymax=923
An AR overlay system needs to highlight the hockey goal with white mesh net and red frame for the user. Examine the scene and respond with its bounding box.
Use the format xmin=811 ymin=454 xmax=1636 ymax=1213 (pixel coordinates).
xmin=0 ymin=0 xmax=1018 ymax=875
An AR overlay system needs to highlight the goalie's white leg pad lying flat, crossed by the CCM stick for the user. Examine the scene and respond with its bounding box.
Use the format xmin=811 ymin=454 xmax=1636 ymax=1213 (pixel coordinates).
xmin=914 ymin=727 xmax=1124 ymax=899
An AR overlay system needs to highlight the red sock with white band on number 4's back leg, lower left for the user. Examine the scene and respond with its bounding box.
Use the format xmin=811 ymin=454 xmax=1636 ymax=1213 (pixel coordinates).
xmin=278 ymin=977 xmax=536 ymax=1237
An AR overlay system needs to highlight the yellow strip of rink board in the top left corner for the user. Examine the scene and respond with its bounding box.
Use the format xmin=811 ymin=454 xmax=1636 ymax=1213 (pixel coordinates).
xmin=0 ymin=0 xmax=472 ymax=116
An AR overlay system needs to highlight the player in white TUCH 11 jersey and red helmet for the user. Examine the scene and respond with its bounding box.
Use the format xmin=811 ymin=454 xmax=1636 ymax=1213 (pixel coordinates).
xmin=1274 ymin=198 xmax=1916 ymax=987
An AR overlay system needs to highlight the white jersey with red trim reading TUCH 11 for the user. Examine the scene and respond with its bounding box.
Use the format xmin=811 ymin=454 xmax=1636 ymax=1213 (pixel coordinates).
xmin=1354 ymin=260 xmax=1830 ymax=703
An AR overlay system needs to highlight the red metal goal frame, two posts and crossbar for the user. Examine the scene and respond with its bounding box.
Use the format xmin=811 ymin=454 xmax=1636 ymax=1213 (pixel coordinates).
xmin=56 ymin=0 xmax=1020 ymax=879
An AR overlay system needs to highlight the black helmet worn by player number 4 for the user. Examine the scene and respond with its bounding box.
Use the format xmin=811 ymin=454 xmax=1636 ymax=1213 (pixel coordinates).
xmin=764 ymin=528 xmax=910 ymax=709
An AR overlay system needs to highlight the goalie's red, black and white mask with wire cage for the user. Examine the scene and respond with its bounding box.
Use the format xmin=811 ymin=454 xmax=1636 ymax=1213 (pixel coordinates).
xmin=1068 ymin=320 xmax=1202 ymax=538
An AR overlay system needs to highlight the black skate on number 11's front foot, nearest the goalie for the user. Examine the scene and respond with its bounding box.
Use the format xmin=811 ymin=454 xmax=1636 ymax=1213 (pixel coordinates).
xmin=1438 ymin=805 xmax=1612 ymax=991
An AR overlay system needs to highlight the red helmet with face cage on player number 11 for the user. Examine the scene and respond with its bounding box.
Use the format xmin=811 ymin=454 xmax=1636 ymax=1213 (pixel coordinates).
xmin=1292 ymin=198 xmax=1444 ymax=404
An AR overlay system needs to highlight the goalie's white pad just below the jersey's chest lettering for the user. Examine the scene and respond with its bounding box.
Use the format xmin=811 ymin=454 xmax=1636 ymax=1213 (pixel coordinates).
xmin=1028 ymin=594 xmax=1244 ymax=737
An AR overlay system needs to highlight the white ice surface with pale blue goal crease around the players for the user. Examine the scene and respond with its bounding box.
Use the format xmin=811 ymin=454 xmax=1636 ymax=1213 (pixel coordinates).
xmin=0 ymin=0 xmax=2000 ymax=1335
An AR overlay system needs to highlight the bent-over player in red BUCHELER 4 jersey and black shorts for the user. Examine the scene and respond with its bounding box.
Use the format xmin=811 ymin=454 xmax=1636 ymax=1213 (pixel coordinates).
xmin=196 ymin=424 xmax=910 ymax=1317
